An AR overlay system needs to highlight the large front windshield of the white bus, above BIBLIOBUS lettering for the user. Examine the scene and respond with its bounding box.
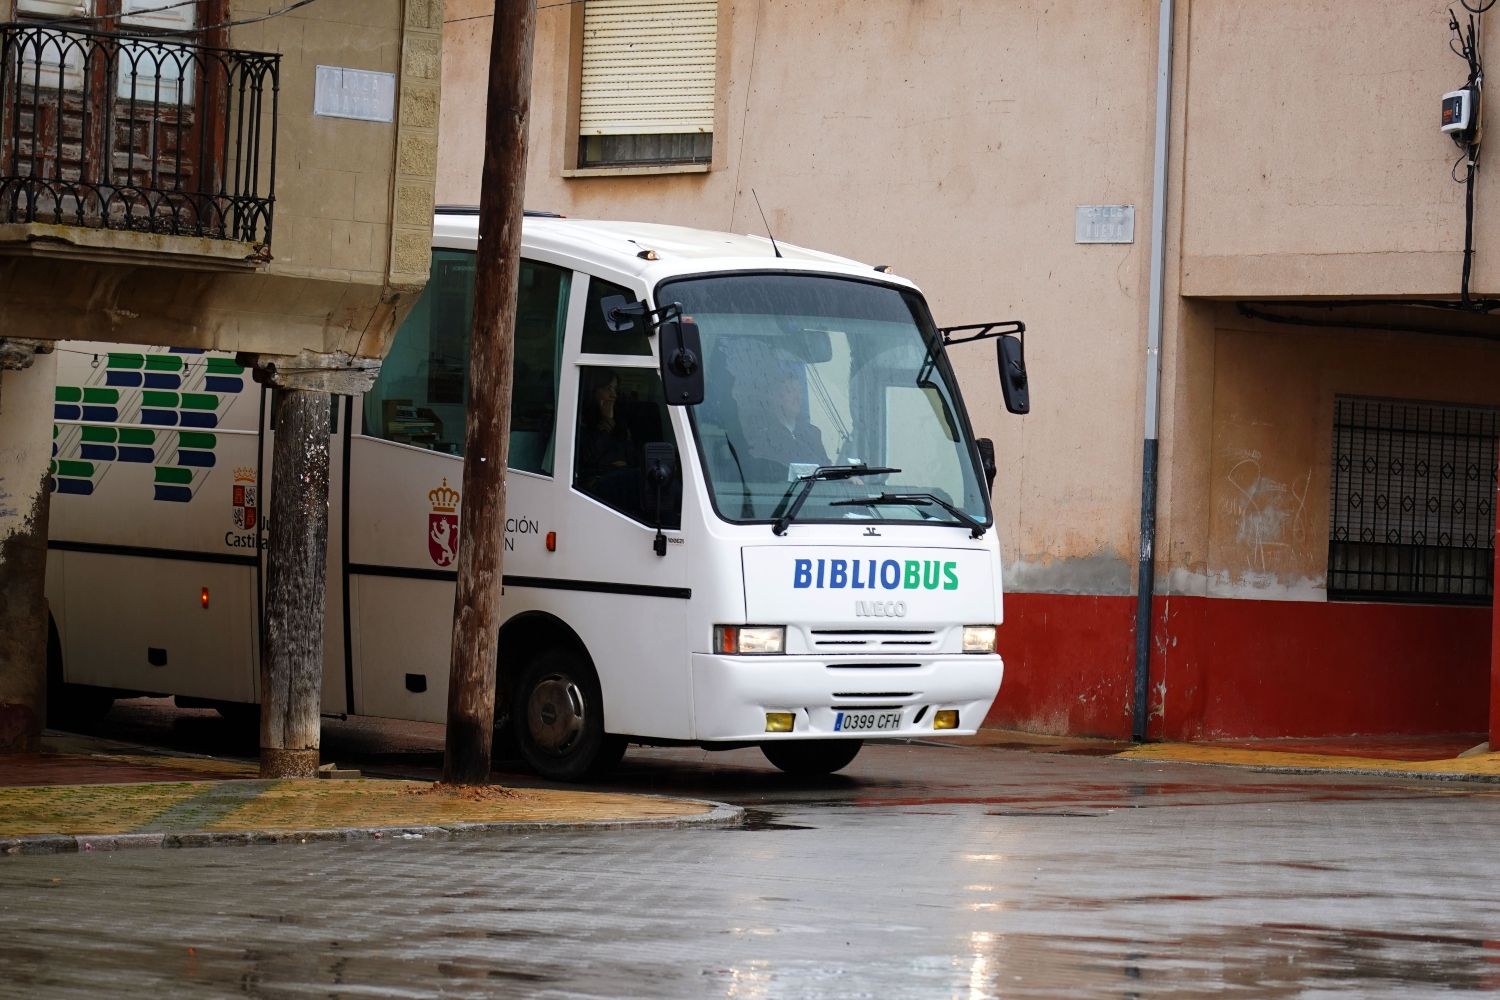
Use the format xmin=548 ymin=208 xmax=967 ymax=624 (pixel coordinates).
xmin=657 ymin=273 xmax=990 ymax=531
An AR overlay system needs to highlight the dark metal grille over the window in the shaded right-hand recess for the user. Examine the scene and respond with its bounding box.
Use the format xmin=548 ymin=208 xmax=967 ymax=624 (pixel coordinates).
xmin=1328 ymin=396 xmax=1500 ymax=604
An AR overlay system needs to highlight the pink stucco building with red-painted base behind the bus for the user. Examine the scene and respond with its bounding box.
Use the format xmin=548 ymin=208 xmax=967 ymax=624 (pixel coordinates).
xmin=438 ymin=0 xmax=1500 ymax=739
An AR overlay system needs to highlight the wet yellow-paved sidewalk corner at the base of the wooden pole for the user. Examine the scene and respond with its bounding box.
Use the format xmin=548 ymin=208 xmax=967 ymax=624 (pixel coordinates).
xmin=0 ymin=733 xmax=743 ymax=855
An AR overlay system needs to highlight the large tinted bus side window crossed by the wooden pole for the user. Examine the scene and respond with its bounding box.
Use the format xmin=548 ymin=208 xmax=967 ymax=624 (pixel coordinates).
xmin=363 ymin=249 xmax=572 ymax=475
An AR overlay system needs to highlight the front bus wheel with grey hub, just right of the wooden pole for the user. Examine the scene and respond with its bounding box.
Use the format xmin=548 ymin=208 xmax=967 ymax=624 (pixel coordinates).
xmin=510 ymin=649 xmax=626 ymax=781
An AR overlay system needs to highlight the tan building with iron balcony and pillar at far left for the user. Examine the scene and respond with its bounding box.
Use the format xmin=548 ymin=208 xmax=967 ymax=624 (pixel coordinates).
xmin=0 ymin=0 xmax=443 ymax=748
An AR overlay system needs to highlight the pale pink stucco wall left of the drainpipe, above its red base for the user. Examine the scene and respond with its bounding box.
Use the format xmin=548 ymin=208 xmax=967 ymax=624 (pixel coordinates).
xmin=438 ymin=0 xmax=1157 ymax=592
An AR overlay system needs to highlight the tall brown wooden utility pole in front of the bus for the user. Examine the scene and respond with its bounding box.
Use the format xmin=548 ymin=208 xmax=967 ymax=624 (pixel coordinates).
xmin=443 ymin=0 xmax=537 ymax=786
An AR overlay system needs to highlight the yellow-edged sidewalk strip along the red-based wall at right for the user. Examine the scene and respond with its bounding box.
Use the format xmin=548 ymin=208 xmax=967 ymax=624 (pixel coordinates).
xmin=951 ymin=729 xmax=1500 ymax=781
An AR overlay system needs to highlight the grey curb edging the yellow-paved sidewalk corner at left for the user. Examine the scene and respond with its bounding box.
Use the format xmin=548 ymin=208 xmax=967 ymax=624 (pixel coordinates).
xmin=0 ymin=796 xmax=746 ymax=856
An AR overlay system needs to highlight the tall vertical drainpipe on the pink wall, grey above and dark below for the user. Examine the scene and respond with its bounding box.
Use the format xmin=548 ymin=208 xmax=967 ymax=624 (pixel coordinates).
xmin=1131 ymin=0 xmax=1175 ymax=742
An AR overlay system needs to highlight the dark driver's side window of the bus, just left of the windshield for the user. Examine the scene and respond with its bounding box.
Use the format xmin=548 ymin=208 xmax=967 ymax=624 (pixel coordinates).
xmin=573 ymin=364 xmax=683 ymax=528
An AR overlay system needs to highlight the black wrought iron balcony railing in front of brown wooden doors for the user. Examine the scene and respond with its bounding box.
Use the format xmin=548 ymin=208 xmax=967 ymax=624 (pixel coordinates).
xmin=0 ymin=22 xmax=281 ymax=244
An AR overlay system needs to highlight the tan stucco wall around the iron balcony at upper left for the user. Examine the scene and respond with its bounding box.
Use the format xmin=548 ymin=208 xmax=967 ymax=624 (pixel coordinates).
xmin=0 ymin=0 xmax=443 ymax=357
